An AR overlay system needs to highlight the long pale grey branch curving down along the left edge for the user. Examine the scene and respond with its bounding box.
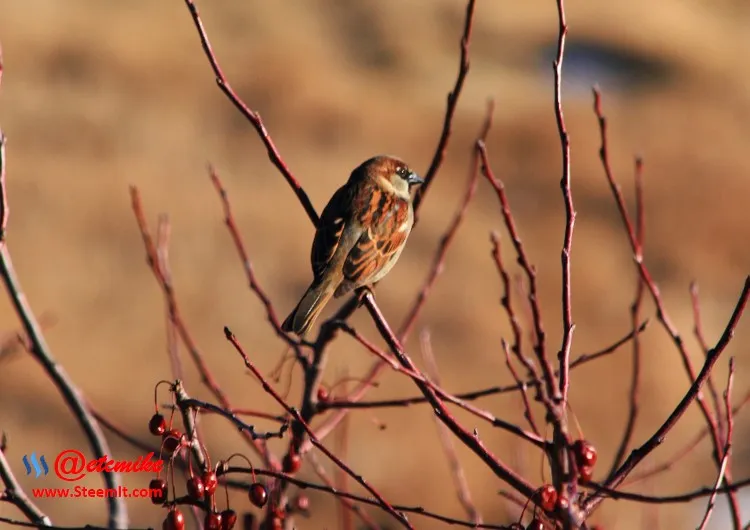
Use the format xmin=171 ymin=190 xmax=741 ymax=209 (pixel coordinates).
xmin=0 ymin=131 xmax=128 ymax=528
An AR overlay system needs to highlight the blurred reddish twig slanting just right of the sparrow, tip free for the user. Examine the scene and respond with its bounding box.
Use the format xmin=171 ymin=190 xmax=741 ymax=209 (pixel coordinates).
xmin=398 ymin=100 xmax=495 ymax=342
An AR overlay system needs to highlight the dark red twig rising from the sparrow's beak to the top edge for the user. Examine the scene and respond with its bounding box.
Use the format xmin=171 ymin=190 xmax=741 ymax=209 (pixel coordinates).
xmin=414 ymin=0 xmax=476 ymax=218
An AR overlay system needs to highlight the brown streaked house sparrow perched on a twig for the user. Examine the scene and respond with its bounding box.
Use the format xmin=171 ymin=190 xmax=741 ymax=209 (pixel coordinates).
xmin=281 ymin=156 xmax=424 ymax=336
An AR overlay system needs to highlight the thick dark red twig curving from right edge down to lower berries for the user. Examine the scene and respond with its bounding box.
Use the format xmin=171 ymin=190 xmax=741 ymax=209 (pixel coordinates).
xmin=584 ymin=276 xmax=750 ymax=512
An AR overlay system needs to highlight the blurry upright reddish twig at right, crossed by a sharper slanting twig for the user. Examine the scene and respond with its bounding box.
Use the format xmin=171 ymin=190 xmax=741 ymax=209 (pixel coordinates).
xmin=608 ymin=158 xmax=646 ymax=476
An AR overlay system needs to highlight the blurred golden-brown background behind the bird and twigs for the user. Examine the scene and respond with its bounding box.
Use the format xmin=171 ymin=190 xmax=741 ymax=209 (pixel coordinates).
xmin=0 ymin=0 xmax=750 ymax=529
